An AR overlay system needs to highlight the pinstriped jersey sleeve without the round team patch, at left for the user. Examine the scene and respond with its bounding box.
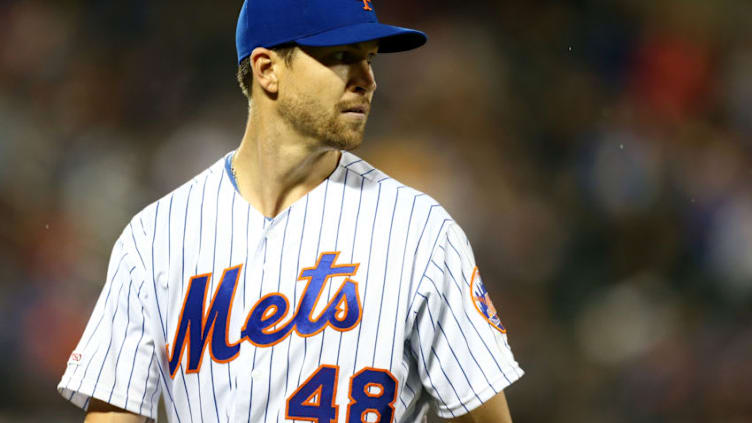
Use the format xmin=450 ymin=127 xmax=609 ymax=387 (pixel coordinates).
xmin=57 ymin=235 xmax=159 ymax=419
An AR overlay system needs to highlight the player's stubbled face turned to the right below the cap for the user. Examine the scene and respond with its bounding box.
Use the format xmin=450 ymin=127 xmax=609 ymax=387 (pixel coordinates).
xmin=278 ymin=41 xmax=378 ymax=150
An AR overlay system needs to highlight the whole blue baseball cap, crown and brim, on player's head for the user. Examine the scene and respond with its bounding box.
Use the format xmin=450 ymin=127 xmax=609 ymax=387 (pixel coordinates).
xmin=235 ymin=0 xmax=428 ymax=63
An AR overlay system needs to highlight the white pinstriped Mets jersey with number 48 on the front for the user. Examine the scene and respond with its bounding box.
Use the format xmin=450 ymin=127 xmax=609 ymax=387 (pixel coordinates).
xmin=58 ymin=152 xmax=523 ymax=423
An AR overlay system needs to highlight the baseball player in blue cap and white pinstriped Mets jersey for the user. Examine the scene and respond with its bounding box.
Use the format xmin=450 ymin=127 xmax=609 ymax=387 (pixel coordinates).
xmin=58 ymin=0 xmax=523 ymax=423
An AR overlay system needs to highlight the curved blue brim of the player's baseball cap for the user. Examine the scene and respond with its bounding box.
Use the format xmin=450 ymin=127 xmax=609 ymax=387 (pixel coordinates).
xmin=295 ymin=22 xmax=428 ymax=53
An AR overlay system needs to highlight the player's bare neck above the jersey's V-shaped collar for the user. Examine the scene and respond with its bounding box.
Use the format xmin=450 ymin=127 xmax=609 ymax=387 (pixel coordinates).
xmin=233 ymin=107 xmax=340 ymax=217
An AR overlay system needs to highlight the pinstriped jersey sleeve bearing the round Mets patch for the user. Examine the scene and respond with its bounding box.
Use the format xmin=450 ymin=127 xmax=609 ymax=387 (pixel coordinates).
xmin=409 ymin=222 xmax=524 ymax=418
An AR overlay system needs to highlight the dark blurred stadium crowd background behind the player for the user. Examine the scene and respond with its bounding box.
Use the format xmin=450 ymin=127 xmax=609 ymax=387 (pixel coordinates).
xmin=0 ymin=0 xmax=752 ymax=423
